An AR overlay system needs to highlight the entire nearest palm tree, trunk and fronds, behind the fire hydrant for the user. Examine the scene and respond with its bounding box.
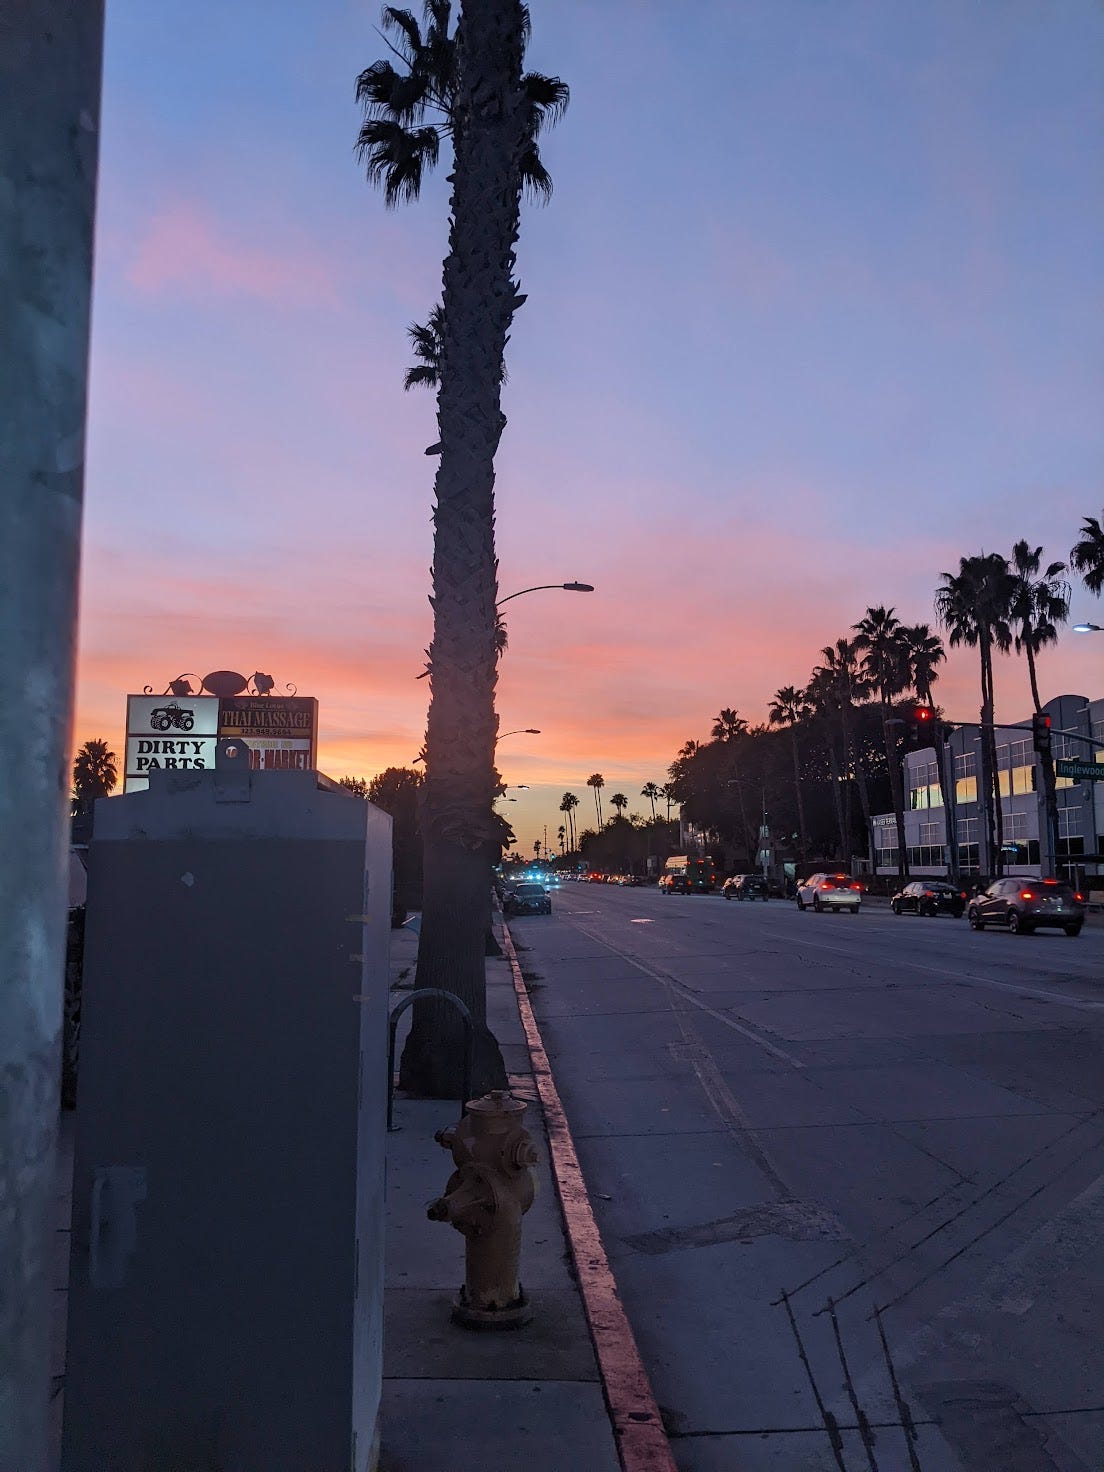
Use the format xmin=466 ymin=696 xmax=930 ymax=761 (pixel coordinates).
xmin=356 ymin=0 xmax=567 ymax=1097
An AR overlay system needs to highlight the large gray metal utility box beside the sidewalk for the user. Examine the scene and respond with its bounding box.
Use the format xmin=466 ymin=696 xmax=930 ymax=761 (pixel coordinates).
xmin=62 ymin=770 xmax=392 ymax=1472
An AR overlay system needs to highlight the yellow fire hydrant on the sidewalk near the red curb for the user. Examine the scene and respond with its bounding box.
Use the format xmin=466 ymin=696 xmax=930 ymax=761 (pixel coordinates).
xmin=425 ymin=1089 xmax=537 ymax=1329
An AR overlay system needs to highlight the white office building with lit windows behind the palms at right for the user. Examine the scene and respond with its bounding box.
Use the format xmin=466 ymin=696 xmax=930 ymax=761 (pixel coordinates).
xmin=871 ymin=695 xmax=1104 ymax=883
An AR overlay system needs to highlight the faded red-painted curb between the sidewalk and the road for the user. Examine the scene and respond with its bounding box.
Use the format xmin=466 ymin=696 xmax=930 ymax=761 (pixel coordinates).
xmin=502 ymin=917 xmax=677 ymax=1472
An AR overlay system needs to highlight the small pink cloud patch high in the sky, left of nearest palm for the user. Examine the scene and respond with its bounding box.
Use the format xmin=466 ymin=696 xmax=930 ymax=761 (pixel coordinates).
xmin=127 ymin=200 xmax=339 ymax=306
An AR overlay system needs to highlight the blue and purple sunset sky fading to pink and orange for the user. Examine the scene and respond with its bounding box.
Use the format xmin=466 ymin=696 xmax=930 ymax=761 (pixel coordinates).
xmin=75 ymin=0 xmax=1104 ymax=851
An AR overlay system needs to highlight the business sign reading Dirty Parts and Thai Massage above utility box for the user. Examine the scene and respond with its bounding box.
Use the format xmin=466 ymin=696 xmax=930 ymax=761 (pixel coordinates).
xmin=124 ymin=695 xmax=318 ymax=792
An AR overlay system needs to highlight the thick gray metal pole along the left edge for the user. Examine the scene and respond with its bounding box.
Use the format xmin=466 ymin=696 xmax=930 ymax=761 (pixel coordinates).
xmin=0 ymin=0 xmax=103 ymax=1472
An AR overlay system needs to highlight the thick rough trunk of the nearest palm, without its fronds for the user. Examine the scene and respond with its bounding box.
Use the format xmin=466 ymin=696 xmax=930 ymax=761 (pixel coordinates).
xmin=400 ymin=0 xmax=527 ymax=1098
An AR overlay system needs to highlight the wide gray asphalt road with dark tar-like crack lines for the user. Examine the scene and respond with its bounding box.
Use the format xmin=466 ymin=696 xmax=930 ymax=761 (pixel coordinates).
xmin=511 ymin=885 xmax=1104 ymax=1472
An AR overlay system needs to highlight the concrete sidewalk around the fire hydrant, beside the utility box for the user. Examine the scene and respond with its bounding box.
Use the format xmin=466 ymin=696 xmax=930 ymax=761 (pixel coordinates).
xmin=380 ymin=929 xmax=618 ymax=1472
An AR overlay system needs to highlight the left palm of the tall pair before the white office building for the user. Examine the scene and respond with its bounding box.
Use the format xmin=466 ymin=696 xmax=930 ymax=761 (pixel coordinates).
xmin=935 ymin=552 xmax=1014 ymax=876
